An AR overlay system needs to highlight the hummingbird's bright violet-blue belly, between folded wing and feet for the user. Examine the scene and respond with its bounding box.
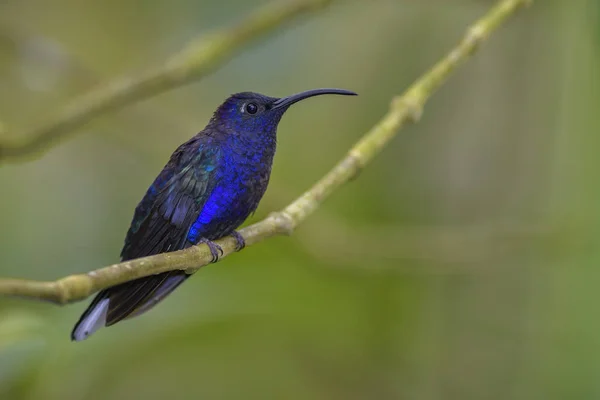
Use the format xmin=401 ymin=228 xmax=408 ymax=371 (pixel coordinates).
xmin=188 ymin=180 xmax=264 ymax=244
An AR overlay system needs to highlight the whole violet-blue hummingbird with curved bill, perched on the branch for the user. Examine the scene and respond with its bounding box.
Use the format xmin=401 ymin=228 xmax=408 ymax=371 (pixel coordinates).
xmin=71 ymin=88 xmax=356 ymax=341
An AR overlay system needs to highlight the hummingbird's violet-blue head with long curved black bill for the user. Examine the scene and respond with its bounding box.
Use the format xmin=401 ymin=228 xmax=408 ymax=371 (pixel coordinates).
xmin=211 ymin=89 xmax=356 ymax=139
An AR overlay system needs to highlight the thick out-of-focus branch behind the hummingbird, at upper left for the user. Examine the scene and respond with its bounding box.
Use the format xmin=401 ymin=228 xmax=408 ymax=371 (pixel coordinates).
xmin=0 ymin=0 xmax=333 ymax=162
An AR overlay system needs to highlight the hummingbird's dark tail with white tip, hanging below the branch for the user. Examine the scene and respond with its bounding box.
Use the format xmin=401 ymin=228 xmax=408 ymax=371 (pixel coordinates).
xmin=71 ymin=271 xmax=190 ymax=341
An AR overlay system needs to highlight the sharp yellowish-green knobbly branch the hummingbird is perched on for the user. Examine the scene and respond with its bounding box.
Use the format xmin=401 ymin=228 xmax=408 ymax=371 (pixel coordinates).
xmin=0 ymin=0 xmax=530 ymax=304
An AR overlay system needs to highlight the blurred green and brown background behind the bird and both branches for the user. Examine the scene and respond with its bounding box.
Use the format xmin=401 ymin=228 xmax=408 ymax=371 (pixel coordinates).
xmin=0 ymin=0 xmax=600 ymax=400
